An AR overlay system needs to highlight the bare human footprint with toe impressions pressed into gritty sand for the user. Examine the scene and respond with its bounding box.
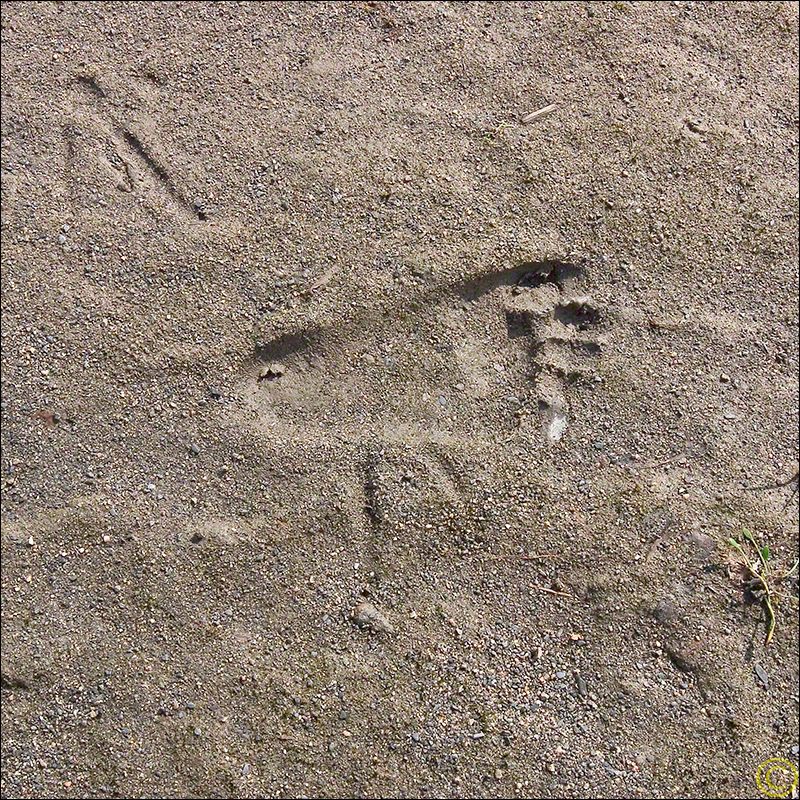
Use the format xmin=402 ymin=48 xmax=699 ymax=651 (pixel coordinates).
xmin=242 ymin=260 xmax=603 ymax=446
